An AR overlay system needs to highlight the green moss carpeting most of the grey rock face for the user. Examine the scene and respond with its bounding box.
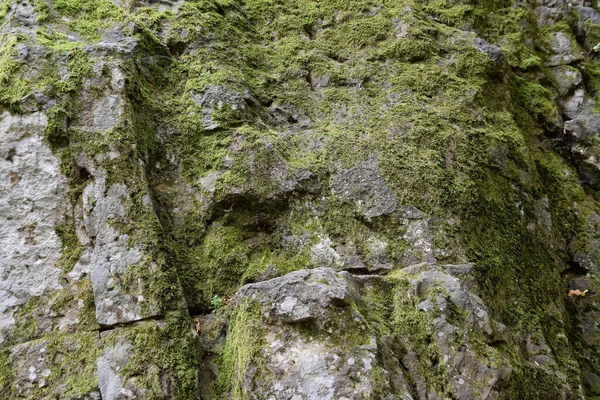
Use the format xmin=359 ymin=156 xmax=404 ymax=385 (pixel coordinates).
xmin=0 ymin=0 xmax=600 ymax=398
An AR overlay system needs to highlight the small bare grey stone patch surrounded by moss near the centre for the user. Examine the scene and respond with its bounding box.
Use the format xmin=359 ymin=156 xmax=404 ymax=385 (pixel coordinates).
xmin=331 ymin=157 xmax=398 ymax=219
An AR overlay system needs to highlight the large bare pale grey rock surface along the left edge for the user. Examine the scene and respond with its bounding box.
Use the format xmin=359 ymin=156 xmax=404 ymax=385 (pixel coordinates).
xmin=0 ymin=111 xmax=70 ymax=344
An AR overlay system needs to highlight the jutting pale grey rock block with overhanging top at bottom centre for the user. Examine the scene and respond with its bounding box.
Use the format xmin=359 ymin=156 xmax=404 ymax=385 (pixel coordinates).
xmin=236 ymin=268 xmax=412 ymax=400
